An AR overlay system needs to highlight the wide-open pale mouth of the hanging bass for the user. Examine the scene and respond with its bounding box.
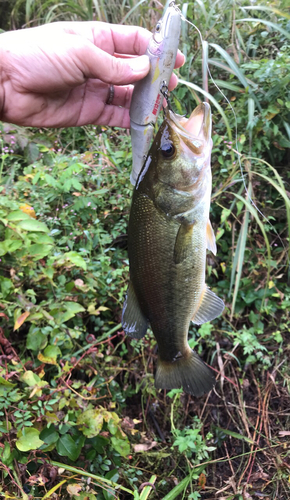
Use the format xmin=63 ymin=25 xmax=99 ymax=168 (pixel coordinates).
xmin=167 ymin=102 xmax=211 ymax=152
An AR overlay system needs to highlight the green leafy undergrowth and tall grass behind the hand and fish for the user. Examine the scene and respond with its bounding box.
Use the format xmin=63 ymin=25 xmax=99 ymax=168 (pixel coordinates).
xmin=0 ymin=0 xmax=290 ymax=500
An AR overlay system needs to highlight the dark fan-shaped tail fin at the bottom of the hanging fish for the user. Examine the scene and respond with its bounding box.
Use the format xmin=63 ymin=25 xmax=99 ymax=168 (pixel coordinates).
xmin=155 ymin=350 xmax=215 ymax=396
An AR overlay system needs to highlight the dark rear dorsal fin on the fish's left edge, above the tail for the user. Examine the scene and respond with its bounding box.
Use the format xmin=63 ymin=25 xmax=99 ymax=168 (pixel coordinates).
xmin=122 ymin=281 xmax=148 ymax=339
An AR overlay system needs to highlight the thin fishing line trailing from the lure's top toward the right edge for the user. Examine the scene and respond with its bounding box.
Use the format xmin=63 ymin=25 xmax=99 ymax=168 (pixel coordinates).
xmin=178 ymin=9 xmax=289 ymax=264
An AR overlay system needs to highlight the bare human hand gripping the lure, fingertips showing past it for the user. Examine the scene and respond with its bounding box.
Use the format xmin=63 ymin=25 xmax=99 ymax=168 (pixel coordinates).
xmin=0 ymin=22 xmax=184 ymax=128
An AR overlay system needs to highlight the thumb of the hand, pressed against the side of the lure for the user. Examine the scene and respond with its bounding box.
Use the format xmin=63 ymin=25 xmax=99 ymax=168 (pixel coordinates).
xmin=82 ymin=46 xmax=150 ymax=85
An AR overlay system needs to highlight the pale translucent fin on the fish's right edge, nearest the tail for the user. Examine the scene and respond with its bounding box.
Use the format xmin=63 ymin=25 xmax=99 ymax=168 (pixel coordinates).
xmin=191 ymin=285 xmax=225 ymax=325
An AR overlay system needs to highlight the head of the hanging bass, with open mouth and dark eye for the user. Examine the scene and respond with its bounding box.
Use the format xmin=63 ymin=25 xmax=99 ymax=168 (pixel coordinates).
xmin=145 ymin=103 xmax=212 ymax=194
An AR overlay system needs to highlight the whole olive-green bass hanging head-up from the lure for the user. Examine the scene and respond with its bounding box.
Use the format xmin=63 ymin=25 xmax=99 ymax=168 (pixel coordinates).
xmin=122 ymin=102 xmax=224 ymax=396
